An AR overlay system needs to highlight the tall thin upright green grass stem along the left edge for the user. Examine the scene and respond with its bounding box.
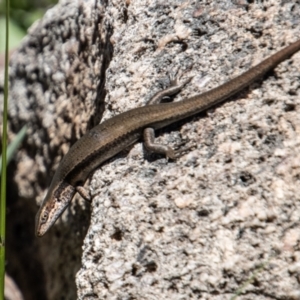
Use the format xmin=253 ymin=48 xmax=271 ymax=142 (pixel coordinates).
xmin=0 ymin=0 xmax=9 ymax=300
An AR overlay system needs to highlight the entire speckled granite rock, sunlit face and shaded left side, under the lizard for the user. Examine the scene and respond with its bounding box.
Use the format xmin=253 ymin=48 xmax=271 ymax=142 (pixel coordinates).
xmin=1 ymin=0 xmax=300 ymax=299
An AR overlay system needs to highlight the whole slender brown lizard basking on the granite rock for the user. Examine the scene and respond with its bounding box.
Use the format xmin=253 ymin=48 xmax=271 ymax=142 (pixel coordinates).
xmin=35 ymin=40 xmax=300 ymax=237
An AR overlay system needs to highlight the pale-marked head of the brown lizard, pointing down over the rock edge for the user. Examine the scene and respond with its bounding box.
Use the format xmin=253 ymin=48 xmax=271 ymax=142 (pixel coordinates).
xmin=35 ymin=182 xmax=76 ymax=237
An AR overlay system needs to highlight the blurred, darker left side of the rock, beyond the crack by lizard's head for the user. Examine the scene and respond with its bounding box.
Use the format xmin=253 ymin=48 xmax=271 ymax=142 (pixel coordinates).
xmin=7 ymin=1 xmax=112 ymax=299
